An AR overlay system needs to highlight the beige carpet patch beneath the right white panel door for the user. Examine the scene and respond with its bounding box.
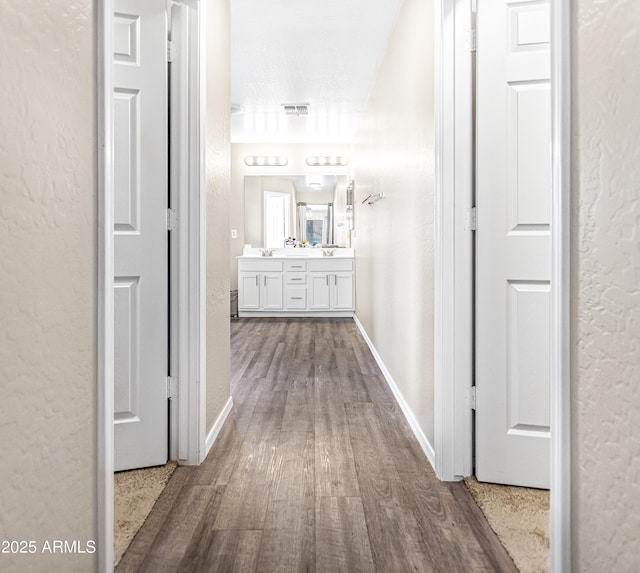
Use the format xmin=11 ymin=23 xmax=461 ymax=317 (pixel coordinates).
xmin=465 ymin=478 xmax=549 ymax=573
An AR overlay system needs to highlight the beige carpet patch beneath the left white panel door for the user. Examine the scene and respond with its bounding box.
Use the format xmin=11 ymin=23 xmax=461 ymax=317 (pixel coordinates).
xmin=113 ymin=462 xmax=176 ymax=565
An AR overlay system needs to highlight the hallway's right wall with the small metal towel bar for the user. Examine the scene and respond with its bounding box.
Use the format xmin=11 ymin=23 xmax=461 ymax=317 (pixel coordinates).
xmin=351 ymin=0 xmax=435 ymax=444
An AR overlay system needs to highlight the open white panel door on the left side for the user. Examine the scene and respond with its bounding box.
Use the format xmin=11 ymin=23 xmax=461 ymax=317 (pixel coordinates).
xmin=113 ymin=0 xmax=168 ymax=470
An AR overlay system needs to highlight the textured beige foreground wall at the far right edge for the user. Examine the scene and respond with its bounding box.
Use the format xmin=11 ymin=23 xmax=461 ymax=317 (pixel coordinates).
xmin=572 ymin=0 xmax=640 ymax=572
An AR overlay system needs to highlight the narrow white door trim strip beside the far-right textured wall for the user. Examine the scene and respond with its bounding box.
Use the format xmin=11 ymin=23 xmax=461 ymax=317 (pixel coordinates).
xmin=550 ymin=0 xmax=572 ymax=573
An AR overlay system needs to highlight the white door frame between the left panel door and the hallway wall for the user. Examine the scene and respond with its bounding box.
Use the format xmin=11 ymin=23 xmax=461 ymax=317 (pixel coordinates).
xmin=167 ymin=0 xmax=206 ymax=465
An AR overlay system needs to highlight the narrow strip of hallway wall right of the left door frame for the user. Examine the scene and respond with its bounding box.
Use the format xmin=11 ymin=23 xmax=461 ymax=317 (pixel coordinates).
xmin=206 ymin=0 xmax=231 ymax=432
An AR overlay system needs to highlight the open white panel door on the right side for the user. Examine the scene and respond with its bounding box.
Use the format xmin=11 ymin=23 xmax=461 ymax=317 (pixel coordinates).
xmin=476 ymin=0 xmax=551 ymax=488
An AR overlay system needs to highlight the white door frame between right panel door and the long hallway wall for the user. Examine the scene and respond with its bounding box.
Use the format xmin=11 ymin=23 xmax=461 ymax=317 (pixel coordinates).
xmin=434 ymin=0 xmax=474 ymax=481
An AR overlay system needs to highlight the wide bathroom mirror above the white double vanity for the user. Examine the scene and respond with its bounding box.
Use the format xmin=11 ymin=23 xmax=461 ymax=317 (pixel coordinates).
xmin=244 ymin=174 xmax=349 ymax=248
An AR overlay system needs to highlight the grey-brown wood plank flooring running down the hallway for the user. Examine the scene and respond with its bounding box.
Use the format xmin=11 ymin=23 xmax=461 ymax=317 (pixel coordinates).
xmin=117 ymin=318 xmax=517 ymax=573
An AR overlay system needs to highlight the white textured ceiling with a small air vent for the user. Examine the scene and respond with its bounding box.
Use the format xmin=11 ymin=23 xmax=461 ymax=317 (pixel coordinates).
xmin=231 ymin=0 xmax=402 ymax=143
